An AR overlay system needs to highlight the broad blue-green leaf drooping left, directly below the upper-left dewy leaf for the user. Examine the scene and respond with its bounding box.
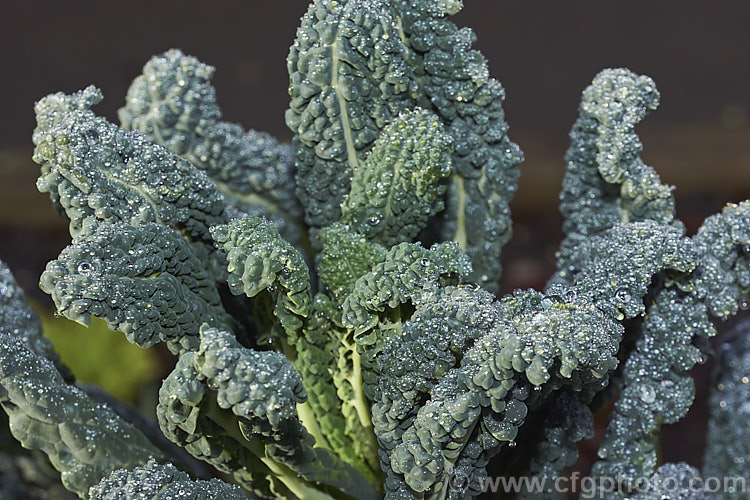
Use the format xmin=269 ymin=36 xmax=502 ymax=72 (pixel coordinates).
xmin=40 ymin=219 xmax=234 ymax=353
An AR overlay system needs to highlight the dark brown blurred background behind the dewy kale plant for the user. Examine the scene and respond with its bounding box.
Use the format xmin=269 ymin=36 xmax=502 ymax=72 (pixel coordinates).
xmin=0 ymin=0 xmax=750 ymax=484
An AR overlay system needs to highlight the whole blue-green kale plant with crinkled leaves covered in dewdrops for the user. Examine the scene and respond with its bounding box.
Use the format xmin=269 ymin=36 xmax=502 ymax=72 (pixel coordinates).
xmin=0 ymin=0 xmax=750 ymax=499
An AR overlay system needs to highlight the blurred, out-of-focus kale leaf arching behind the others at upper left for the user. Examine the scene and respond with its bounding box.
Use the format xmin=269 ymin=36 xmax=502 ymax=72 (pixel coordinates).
xmin=118 ymin=49 xmax=302 ymax=247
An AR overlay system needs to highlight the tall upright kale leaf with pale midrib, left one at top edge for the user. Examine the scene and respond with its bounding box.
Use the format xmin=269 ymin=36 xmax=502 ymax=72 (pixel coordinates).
xmin=286 ymin=0 xmax=416 ymax=229
